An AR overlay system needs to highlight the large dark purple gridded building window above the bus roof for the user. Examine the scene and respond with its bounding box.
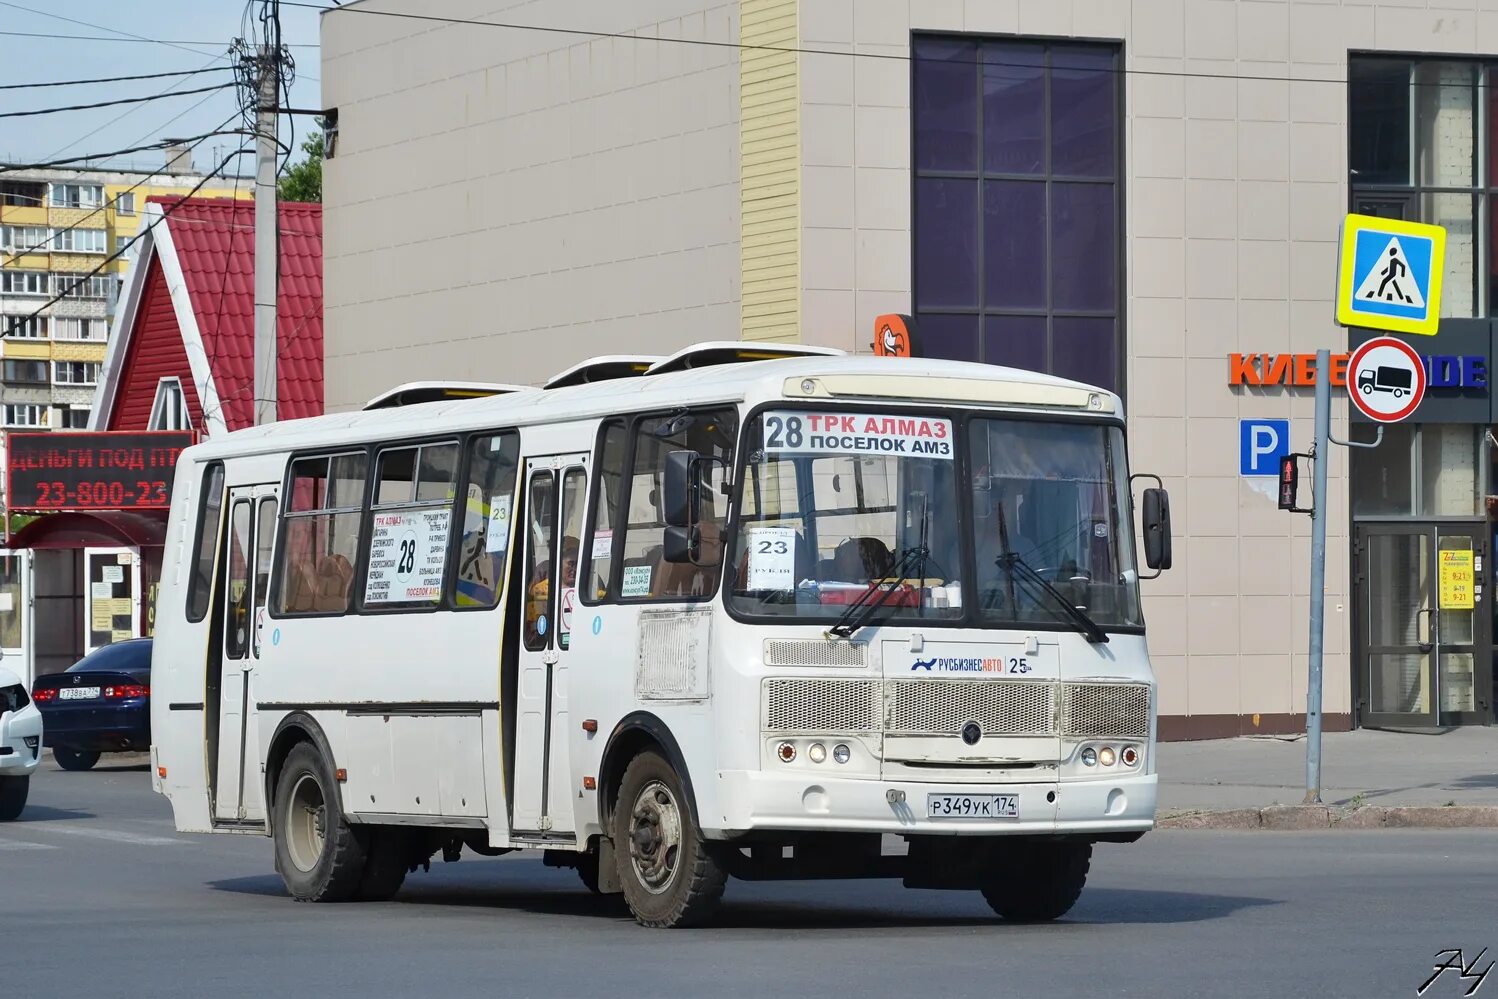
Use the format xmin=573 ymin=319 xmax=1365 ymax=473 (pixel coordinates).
xmin=912 ymin=36 xmax=1125 ymax=388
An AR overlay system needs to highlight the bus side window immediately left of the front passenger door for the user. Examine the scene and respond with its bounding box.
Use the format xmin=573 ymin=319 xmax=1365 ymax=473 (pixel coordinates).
xmin=449 ymin=433 xmax=520 ymax=608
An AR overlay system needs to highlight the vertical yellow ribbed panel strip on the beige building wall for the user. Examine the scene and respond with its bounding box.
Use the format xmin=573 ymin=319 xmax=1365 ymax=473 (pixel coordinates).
xmin=739 ymin=0 xmax=801 ymax=343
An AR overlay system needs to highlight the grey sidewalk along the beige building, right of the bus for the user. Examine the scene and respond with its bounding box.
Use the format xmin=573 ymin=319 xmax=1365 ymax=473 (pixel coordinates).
xmin=1158 ymin=726 xmax=1498 ymax=828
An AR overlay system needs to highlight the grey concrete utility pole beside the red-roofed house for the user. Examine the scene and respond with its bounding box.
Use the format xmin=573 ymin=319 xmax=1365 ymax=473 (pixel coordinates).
xmin=255 ymin=42 xmax=280 ymax=425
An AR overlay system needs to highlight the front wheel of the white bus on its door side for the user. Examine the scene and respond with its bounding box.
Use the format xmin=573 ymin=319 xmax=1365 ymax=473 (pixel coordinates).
xmin=613 ymin=750 xmax=728 ymax=929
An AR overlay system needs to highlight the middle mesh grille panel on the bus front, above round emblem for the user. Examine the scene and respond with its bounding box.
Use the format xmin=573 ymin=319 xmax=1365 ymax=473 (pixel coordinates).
xmin=885 ymin=680 xmax=1056 ymax=735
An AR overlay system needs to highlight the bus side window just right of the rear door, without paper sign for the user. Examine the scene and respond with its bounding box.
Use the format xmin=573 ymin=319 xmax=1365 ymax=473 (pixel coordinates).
xmin=274 ymin=451 xmax=369 ymax=614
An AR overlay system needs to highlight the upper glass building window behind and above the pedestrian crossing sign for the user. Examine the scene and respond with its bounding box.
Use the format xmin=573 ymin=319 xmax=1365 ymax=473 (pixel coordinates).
xmin=1348 ymin=55 xmax=1498 ymax=319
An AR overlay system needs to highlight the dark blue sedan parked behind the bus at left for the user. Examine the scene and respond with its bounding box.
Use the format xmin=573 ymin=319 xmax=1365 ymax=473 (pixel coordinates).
xmin=31 ymin=638 xmax=151 ymax=770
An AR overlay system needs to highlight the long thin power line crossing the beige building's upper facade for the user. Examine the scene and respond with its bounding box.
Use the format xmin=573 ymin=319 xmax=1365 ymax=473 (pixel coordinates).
xmin=301 ymin=0 xmax=1473 ymax=87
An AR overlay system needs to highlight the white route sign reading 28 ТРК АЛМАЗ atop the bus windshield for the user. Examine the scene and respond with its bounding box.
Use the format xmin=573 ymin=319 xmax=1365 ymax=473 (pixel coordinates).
xmin=764 ymin=412 xmax=954 ymax=460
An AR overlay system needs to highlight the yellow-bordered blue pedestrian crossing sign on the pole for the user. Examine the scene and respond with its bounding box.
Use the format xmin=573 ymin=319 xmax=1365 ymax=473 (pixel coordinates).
xmin=1336 ymin=214 xmax=1446 ymax=335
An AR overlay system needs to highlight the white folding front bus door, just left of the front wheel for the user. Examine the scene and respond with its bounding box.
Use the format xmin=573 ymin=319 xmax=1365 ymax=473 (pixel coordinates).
xmin=506 ymin=455 xmax=587 ymax=837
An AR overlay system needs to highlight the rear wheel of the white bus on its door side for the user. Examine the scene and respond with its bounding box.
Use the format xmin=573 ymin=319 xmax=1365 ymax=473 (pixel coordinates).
xmin=273 ymin=743 xmax=369 ymax=902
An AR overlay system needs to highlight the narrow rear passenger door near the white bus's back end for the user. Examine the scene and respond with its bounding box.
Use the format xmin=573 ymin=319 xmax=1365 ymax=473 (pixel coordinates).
xmin=210 ymin=485 xmax=277 ymax=822
